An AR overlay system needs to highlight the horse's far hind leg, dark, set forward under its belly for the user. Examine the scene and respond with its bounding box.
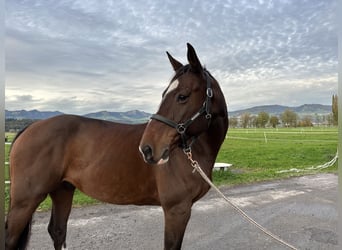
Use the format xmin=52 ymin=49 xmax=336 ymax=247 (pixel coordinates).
xmin=48 ymin=182 xmax=75 ymax=250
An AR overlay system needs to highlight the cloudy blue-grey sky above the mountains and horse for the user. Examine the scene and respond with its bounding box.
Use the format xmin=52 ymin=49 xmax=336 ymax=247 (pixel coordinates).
xmin=5 ymin=0 xmax=338 ymax=114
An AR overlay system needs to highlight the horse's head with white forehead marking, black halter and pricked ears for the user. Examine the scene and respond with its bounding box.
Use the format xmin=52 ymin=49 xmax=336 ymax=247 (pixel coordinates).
xmin=139 ymin=44 xmax=227 ymax=164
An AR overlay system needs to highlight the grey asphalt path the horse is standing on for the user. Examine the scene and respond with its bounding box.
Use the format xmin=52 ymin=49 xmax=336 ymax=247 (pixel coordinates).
xmin=28 ymin=174 xmax=340 ymax=250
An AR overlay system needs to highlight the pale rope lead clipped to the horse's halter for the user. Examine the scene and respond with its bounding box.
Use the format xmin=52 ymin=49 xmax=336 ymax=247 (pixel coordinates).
xmin=184 ymin=149 xmax=297 ymax=250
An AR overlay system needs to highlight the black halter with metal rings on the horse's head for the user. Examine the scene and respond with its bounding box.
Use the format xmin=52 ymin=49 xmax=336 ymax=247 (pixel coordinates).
xmin=151 ymin=70 xmax=213 ymax=152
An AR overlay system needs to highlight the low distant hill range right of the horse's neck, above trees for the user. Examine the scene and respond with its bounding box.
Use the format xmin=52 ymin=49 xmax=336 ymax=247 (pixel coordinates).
xmin=229 ymin=104 xmax=332 ymax=117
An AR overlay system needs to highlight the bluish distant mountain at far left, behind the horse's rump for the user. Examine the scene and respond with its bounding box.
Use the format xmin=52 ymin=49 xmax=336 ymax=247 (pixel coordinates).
xmin=5 ymin=109 xmax=63 ymax=120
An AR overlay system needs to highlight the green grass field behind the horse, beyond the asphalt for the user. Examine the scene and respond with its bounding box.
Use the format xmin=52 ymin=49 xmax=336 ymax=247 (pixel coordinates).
xmin=5 ymin=127 xmax=338 ymax=210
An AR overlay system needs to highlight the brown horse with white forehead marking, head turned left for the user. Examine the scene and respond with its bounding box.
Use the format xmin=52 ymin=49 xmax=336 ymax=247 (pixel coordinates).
xmin=5 ymin=44 xmax=228 ymax=249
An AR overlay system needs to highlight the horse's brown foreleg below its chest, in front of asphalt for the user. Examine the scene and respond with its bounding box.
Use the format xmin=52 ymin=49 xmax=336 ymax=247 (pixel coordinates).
xmin=164 ymin=204 xmax=191 ymax=250
